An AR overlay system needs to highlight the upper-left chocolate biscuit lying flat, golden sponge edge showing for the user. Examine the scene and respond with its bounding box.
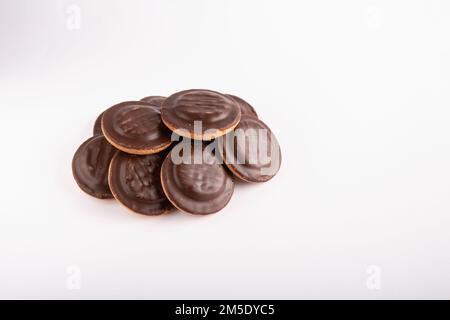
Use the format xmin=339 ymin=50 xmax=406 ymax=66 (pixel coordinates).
xmin=102 ymin=101 xmax=172 ymax=155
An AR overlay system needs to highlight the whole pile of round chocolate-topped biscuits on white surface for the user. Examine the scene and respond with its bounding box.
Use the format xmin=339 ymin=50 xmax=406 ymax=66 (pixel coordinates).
xmin=72 ymin=90 xmax=281 ymax=215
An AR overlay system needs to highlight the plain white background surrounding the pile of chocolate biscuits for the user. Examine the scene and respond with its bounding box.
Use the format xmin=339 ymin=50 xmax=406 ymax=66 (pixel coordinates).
xmin=0 ymin=0 xmax=450 ymax=299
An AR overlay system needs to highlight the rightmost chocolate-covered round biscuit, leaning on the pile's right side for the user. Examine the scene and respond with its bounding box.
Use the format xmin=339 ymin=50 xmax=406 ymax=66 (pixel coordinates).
xmin=217 ymin=115 xmax=281 ymax=182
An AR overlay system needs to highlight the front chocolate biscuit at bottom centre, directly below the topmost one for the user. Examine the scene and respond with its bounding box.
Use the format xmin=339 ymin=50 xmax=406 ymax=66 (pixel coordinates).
xmin=161 ymin=145 xmax=234 ymax=215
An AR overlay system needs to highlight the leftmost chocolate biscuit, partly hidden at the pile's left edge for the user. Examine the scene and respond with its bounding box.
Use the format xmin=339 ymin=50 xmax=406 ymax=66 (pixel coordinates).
xmin=72 ymin=135 xmax=117 ymax=199
